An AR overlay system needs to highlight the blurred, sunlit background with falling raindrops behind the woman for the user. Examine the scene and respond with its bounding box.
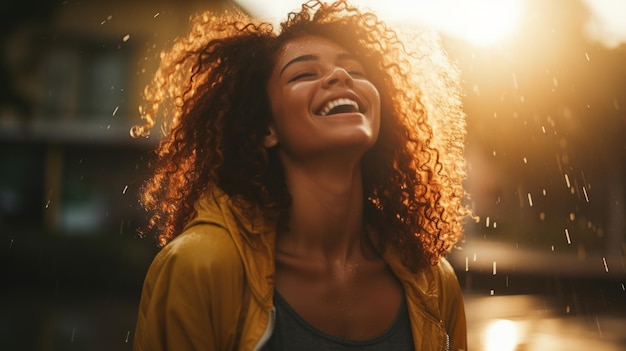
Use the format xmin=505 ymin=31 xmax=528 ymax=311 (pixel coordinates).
xmin=0 ymin=0 xmax=626 ymax=351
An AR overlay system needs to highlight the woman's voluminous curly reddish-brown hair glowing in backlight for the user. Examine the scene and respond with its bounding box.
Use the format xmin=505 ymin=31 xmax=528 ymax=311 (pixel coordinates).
xmin=132 ymin=0 xmax=468 ymax=269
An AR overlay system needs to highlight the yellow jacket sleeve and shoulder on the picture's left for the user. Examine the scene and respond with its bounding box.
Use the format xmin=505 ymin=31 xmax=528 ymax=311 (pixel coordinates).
xmin=133 ymin=225 xmax=243 ymax=351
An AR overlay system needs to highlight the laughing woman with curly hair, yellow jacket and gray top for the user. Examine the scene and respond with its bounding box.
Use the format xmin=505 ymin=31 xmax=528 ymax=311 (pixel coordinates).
xmin=129 ymin=1 xmax=466 ymax=350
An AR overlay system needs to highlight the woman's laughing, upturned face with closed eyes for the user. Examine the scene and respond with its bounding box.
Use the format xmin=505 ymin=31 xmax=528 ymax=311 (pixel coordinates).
xmin=265 ymin=35 xmax=380 ymax=159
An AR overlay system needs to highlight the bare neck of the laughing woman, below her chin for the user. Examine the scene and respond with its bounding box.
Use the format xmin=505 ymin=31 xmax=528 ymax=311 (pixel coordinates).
xmin=277 ymin=158 xmax=363 ymax=264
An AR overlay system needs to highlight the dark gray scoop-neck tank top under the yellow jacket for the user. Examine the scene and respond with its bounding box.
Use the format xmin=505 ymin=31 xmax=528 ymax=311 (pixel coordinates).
xmin=263 ymin=291 xmax=414 ymax=351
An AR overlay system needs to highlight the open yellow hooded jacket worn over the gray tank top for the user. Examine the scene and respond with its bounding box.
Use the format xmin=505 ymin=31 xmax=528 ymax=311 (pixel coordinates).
xmin=134 ymin=191 xmax=467 ymax=351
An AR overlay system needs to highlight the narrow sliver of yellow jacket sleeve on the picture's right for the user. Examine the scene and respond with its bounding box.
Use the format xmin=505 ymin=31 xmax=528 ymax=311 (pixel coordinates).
xmin=437 ymin=259 xmax=467 ymax=351
